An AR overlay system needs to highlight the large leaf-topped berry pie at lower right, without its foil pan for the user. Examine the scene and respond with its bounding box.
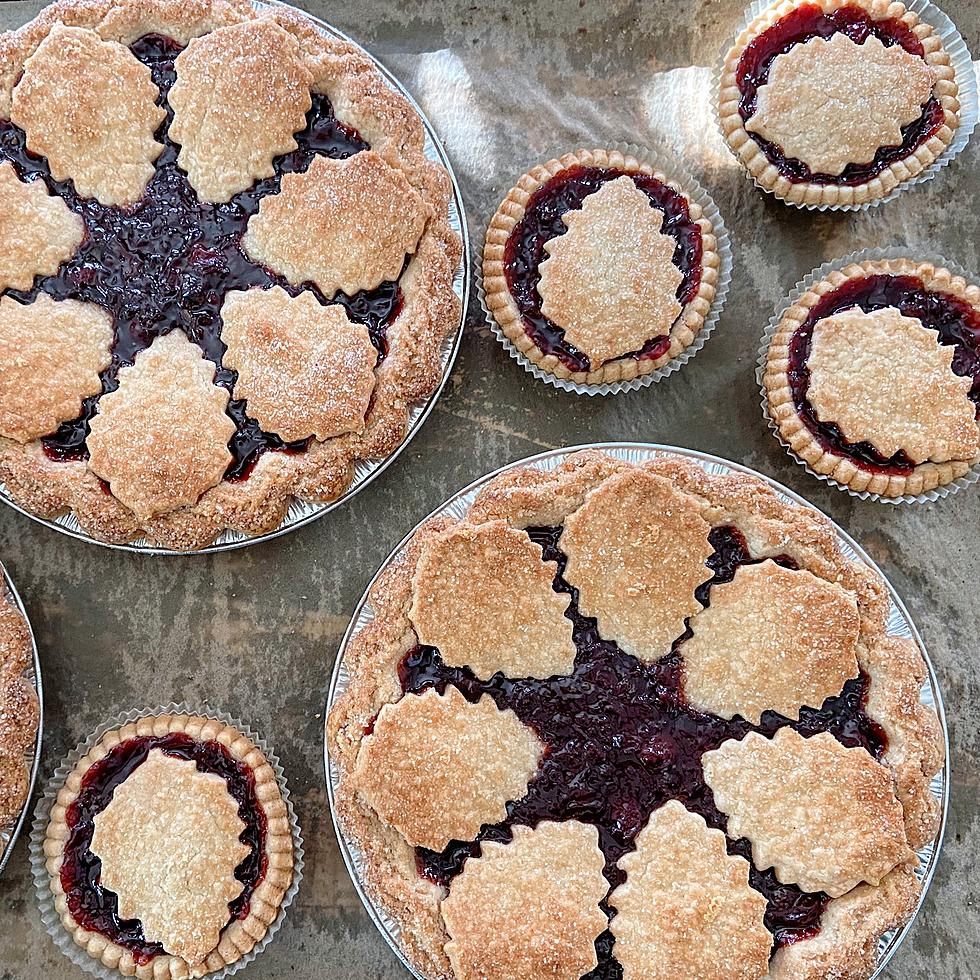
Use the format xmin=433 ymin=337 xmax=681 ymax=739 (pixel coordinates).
xmin=327 ymin=450 xmax=943 ymax=980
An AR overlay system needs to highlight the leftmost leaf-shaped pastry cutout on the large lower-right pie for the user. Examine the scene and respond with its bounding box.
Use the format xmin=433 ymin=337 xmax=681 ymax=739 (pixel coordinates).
xmin=354 ymin=687 xmax=544 ymax=851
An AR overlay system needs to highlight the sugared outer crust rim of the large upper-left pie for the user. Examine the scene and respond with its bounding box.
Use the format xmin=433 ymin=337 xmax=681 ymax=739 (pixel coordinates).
xmin=0 ymin=0 xmax=462 ymax=550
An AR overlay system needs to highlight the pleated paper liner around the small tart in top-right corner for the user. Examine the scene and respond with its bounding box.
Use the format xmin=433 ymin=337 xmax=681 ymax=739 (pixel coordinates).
xmin=711 ymin=0 xmax=980 ymax=211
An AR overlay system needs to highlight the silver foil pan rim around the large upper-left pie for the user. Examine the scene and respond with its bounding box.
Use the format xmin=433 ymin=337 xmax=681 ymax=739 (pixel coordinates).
xmin=0 ymin=0 xmax=471 ymax=555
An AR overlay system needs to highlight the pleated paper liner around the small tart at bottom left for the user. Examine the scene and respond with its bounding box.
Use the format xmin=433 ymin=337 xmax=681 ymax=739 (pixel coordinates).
xmin=31 ymin=704 xmax=304 ymax=980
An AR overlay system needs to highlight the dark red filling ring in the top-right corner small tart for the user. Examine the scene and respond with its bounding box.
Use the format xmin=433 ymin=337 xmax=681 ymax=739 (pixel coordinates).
xmin=735 ymin=3 xmax=945 ymax=185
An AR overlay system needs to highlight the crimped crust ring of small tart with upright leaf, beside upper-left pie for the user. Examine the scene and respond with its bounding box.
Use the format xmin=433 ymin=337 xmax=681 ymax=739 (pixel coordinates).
xmin=483 ymin=149 xmax=721 ymax=385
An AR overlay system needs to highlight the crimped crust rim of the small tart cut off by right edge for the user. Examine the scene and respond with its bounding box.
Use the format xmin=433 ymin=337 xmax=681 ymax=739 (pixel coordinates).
xmin=762 ymin=259 xmax=980 ymax=497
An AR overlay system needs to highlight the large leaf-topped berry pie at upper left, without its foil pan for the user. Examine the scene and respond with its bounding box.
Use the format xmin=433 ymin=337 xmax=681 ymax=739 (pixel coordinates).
xmin=0 ymin=0 xmax=461 ymax=550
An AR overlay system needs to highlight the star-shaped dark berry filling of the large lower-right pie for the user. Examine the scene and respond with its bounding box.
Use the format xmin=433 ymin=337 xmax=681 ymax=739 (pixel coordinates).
xmin=399 ymin=526 xmax=886 ymax=968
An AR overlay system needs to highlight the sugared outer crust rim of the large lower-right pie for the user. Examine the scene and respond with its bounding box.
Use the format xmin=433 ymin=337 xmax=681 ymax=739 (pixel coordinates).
xmin=327 ymin=450 xmax=944 ymax=980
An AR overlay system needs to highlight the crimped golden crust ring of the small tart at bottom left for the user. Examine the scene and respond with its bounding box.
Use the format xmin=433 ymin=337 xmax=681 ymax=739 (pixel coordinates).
xmin=43 ymin=714 xmax=294 ymax=980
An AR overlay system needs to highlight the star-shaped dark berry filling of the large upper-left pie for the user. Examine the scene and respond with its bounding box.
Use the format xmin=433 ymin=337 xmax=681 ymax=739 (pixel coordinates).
xmin=0 ymin=34 xmax=402 ymax=479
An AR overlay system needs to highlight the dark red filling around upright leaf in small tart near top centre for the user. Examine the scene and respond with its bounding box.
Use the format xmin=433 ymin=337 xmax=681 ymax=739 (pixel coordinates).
xmin=504 ymin=167 xmax=702 ymax=371
